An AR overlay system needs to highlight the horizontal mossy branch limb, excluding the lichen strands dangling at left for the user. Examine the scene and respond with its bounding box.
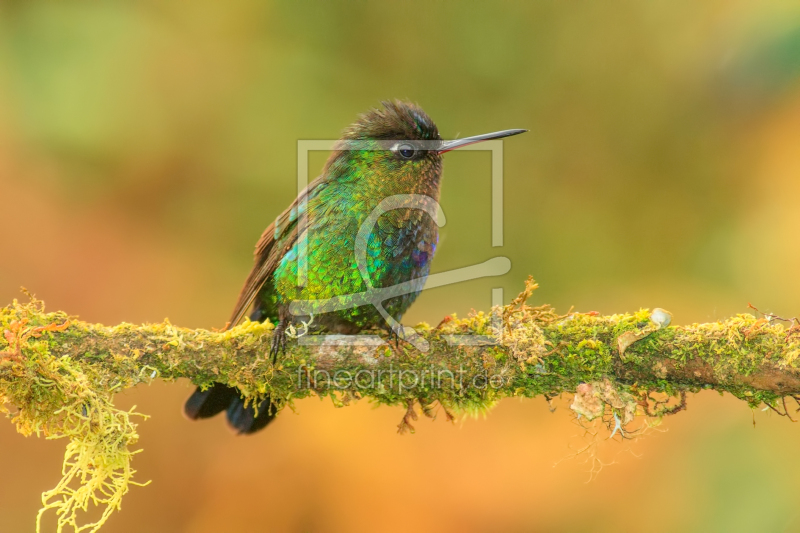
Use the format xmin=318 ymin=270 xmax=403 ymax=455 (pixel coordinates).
xmin=0 ymin=285 xmax=800 ymax=422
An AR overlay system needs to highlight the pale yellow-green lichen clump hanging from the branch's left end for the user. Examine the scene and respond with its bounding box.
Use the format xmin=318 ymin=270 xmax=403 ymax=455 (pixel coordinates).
xmin=0 ymin=301 xmax=146 ymax=533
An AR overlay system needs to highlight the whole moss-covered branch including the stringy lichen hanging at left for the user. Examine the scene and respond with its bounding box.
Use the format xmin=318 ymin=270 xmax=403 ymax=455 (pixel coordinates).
xmin=0 ymin=280 xmax=800 ymax=531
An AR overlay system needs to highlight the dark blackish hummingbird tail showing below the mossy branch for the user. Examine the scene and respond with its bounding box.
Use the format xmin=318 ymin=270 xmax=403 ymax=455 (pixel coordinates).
xmin=183 ymin=383 xmax=275 ymax=435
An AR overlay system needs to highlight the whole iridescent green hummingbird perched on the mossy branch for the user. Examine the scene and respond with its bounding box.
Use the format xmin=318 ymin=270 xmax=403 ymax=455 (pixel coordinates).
xmin=184 ymin=101 xmax=527 ymax=434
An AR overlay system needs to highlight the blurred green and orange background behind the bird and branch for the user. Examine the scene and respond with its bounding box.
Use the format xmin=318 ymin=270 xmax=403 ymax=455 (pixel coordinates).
xmin=0 ymin=0 xmax=800 ymax=533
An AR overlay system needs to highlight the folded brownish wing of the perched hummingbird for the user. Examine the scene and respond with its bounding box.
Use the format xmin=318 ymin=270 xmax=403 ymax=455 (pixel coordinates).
xmin=226 ymin=178 xmax=320 ymax=329
